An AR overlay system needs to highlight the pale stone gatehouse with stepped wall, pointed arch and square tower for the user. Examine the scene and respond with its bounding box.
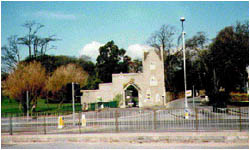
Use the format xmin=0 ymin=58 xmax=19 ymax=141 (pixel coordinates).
xmin=81 ymin=48 xmax=166 ymax=108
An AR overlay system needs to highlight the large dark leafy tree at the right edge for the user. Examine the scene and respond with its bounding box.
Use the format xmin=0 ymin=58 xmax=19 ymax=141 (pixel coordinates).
xmin=204 ymin=22 xmax=249 ymax=103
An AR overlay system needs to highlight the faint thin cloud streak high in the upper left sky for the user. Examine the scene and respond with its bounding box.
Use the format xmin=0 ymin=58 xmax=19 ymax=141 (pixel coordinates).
xmin=34 ymin=11 xmax=76 ymax=20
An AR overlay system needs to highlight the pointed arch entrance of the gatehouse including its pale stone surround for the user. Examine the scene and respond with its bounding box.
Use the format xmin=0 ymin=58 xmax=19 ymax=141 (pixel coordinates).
xmin=123 ymin=83 xmax=141 ymax=107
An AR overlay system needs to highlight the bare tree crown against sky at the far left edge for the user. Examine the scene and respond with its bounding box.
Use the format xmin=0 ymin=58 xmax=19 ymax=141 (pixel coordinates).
xmin=1 ymin=35 xmax=20 ymax=73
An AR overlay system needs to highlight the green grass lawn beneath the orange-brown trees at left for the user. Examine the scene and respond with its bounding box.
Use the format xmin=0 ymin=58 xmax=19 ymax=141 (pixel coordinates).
xmin=1 ymin=96 xmax=81 ymax=114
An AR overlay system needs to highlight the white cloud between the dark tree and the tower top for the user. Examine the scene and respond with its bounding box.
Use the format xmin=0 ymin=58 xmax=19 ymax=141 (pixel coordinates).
xmin=126 ymin=44 xmax=152 ymax=59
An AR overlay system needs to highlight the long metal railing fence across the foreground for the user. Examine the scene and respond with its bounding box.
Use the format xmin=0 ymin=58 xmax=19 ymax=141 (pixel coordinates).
xmin=1 ymin=107 xmax=249 ymax=135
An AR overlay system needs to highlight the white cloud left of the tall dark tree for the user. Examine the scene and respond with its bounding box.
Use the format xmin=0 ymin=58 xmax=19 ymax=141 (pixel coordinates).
xmin=79 ymin=41 xmax=104 ymax=62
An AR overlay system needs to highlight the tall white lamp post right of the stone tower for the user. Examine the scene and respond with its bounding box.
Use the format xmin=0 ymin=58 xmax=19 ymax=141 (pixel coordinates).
xmin=180 ymin=17 xmax=188 ymax=119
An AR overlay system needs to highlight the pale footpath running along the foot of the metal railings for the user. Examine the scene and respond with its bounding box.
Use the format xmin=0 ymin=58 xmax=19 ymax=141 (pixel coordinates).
xmin=1 ymin=131 xmax=249 ymax=144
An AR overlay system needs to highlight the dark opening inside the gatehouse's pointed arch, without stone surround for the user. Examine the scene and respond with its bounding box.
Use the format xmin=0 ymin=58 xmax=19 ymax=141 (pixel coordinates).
xmin=125 ymin=85 xmax=139 ymax=107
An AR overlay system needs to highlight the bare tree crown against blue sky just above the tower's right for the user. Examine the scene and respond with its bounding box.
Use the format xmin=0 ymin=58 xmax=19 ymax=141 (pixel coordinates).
xmin=147 ymin=25 xmax=176 ymax=54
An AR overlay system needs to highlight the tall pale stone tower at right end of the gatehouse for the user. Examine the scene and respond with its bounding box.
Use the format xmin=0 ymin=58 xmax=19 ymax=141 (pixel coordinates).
xmin=142 ymin=49 xmax=166 ymax=106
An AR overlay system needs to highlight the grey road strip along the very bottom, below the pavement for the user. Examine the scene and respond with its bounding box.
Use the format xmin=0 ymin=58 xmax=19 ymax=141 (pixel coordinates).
xmin=2 ymin=143 xmax=249 ymax=149
